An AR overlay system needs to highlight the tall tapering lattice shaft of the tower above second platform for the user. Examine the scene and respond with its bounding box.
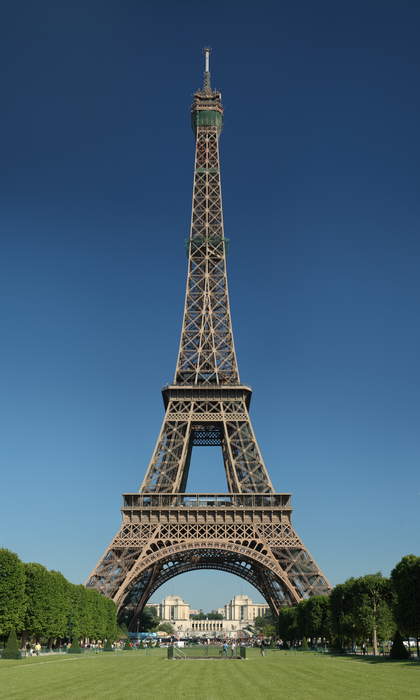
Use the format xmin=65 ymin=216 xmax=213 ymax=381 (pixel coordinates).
xmin=175 ymin=93 xmax=239 ymax=385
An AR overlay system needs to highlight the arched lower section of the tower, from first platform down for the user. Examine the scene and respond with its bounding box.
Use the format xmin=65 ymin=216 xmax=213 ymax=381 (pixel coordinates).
xmin=88 ymin=493 xmax=329 ymax=626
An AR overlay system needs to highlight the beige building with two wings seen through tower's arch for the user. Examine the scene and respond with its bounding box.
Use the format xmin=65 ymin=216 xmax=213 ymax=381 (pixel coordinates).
xmin=148 ymin=595 xmax=269 ymax=637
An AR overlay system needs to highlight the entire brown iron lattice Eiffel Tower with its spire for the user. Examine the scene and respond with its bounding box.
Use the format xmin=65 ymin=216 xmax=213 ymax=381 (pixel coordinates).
xmin=86 ymin=49 xmax=330 ymax=630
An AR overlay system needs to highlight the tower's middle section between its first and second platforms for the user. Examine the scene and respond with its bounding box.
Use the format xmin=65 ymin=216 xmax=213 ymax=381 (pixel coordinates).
xmin=141 ymin=385 xmax=273 ymax=493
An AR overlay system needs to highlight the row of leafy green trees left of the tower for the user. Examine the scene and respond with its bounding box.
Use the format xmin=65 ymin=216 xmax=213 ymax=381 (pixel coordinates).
xmin=0 ymin=549 xmax=118 ymax=645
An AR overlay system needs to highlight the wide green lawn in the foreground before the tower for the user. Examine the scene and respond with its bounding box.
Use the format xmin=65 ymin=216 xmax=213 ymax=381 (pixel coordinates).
xmin=0 ymin=649 xmax=420 ymax=700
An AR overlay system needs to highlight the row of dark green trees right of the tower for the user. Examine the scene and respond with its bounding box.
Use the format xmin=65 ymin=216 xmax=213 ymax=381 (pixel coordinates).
xmin=256 ymin=554 xmax=420 ymax=654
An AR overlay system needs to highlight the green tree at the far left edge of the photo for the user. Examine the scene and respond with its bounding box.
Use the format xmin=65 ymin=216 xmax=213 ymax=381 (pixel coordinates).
xmin=0 ymin=549 xmax=27 ymax=636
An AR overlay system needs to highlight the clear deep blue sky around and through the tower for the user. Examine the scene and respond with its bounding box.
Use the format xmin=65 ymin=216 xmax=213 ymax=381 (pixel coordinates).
xmin=0 ymin=0 xmax=420 ymax=609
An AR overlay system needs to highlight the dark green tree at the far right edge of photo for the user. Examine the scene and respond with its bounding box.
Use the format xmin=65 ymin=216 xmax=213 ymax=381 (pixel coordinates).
xmin=391 ymin=554 xmax=420 ymax=656
